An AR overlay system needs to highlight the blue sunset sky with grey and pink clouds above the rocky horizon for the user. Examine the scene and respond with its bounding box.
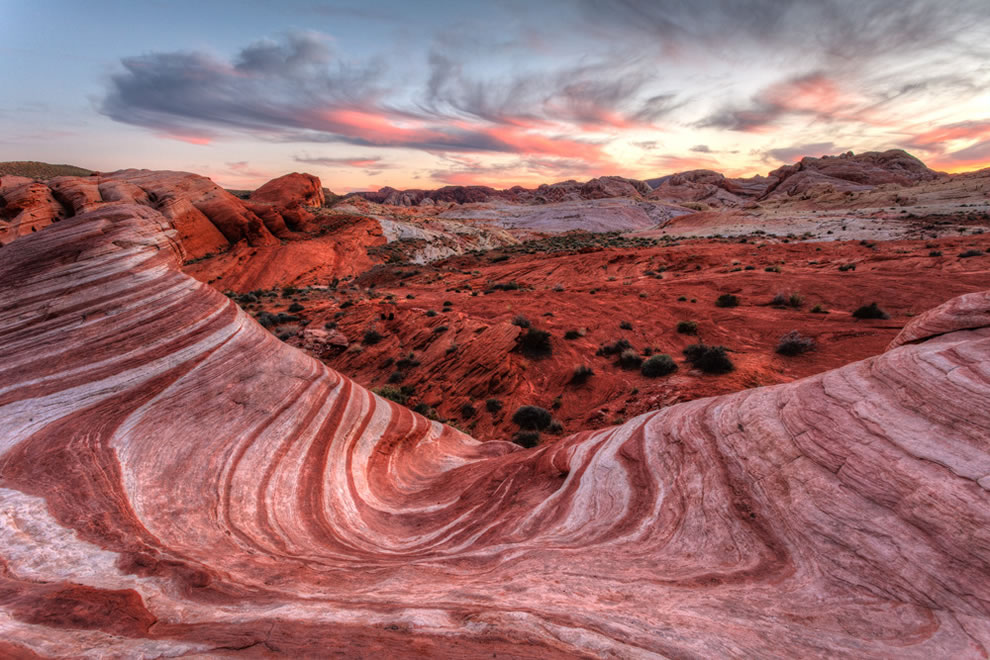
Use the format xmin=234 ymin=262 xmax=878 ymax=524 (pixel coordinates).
xmin=0 ymin=0 xmax=990 ymax=192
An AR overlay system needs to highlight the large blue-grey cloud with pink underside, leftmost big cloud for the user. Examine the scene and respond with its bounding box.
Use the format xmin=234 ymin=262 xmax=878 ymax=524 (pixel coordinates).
xmin=100 ymin=32 xmax=620 ymax=168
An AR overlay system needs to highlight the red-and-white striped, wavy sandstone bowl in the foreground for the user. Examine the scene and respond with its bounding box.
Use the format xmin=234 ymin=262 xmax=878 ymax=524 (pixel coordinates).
xmin=0 ymin=204 xmax=990 ymax=658
